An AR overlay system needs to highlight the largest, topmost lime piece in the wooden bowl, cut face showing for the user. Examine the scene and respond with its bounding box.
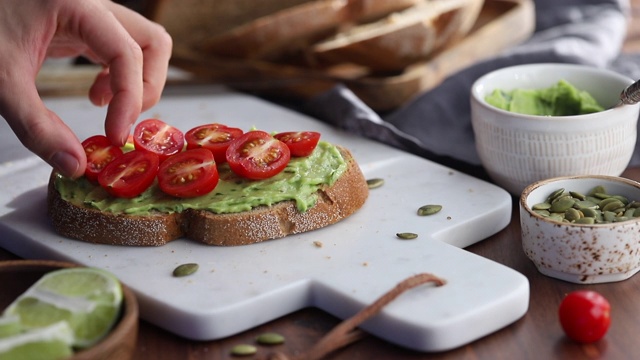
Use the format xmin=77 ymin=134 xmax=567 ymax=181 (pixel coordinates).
xmin=5 ymin=267 xmax=122 ymax=348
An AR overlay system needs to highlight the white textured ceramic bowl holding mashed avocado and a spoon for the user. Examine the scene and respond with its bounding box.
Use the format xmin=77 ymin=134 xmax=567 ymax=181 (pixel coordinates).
xmin=471 ymin=64 xmax=640 ymax=196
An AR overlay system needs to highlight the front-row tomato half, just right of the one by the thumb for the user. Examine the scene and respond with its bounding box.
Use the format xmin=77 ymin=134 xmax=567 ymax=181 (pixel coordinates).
xmin=98 ymin=150 xmax=160 ymax=198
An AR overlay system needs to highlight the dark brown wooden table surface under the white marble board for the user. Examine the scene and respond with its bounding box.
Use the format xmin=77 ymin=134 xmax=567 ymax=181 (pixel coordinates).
xmin=6 ymin=0 xmax=640 ymax=360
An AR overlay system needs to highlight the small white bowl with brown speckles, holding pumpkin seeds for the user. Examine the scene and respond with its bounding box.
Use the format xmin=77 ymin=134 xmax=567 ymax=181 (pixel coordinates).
xmin=520 ymin=176 xmax=640 ymax=284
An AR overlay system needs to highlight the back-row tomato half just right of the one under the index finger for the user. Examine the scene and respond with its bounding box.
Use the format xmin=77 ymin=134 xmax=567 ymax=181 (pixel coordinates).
xmin=184 ymin=124 xmax=244 ymax=163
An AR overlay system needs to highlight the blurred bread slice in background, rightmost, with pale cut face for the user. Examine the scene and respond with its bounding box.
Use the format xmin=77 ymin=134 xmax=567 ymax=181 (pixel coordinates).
xmin=309 ymin=0 xmax=484 ymax=71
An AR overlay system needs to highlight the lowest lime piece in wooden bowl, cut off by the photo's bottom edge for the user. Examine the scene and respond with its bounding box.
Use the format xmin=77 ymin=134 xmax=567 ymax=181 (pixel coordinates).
xmin=0 ymin=321 xmax=73 ymax=360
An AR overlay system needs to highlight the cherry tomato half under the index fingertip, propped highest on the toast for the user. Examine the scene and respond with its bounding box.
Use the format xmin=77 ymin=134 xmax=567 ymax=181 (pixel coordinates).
xmin=133 ymin=119 xmax=184 ymax=161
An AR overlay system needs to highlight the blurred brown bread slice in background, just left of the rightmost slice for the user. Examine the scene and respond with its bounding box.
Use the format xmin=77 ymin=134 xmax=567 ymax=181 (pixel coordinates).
xmin=203 ymin=0 xmax=421 ymax=60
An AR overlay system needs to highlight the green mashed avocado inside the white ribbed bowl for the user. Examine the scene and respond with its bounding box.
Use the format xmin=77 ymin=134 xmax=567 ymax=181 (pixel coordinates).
xmin=485 ymin=80 xmax=604 ymax=116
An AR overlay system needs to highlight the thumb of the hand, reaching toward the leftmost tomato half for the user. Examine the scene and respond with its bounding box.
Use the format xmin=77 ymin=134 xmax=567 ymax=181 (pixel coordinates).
xmin=0 ymin=79 xmax=86 ymax=178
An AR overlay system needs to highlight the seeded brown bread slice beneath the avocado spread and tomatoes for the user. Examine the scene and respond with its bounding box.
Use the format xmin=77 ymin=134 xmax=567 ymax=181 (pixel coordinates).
xmin=47 ymin=147 xmax=369 ymax=246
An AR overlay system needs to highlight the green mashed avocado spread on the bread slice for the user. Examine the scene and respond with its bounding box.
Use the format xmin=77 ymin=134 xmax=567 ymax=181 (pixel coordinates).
xmin=55 ymin=141 xmax=347 ymax=215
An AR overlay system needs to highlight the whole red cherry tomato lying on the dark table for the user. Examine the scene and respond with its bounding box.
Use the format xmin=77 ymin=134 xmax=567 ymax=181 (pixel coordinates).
xmin=558 ymin=290 xmax=611 ymax=343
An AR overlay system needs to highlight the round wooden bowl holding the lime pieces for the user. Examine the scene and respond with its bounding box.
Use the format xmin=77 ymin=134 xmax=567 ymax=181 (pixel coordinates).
xmin=0 ymin=260 xmax=138 ymax=360
